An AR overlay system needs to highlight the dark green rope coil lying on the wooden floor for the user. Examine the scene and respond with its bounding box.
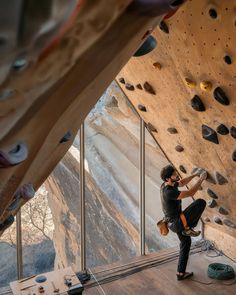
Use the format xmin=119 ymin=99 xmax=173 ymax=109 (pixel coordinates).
xmin=207 ymin=263 xmax=235 ymax=280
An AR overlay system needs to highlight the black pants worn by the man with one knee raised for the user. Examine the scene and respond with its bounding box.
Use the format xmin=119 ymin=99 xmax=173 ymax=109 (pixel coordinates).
xmin=169 ymin=199 xmax=206 ymax=273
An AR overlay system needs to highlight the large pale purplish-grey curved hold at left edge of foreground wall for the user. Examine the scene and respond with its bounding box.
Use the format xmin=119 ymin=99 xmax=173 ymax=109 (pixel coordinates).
xmin=0 ymin=143 xmax=28 ymax=168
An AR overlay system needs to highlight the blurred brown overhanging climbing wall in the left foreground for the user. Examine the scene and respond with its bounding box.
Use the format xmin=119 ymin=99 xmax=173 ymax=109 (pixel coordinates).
xmin=0 ymin=0 xmax=183 ymax=235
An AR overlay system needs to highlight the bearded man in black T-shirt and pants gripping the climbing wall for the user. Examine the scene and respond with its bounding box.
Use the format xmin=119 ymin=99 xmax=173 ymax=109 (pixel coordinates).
xmin=161 ymin=165 xmax=207 ymax=280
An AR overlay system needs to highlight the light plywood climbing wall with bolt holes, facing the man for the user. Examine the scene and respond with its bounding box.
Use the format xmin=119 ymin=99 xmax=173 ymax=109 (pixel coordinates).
xmin=117 ymin=0 xmax=236 ymax=258
